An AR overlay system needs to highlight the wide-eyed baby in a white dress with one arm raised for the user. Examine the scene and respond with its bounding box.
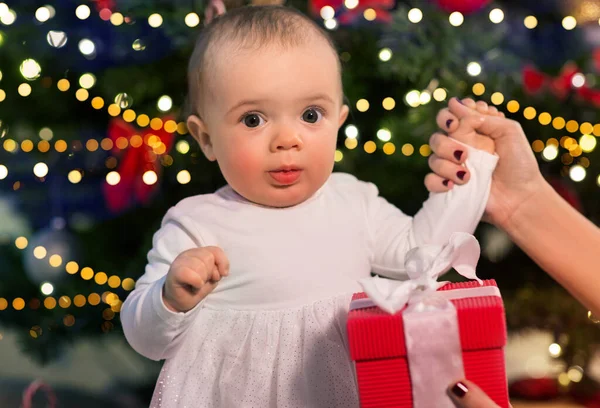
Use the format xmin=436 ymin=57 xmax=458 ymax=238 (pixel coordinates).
xmin=121 ymin=6 xmax=496 ymax=408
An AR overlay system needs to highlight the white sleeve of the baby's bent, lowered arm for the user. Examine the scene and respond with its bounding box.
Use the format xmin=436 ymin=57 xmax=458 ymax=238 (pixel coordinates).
xmin=121 ymin=208 xmax=207 ymax=360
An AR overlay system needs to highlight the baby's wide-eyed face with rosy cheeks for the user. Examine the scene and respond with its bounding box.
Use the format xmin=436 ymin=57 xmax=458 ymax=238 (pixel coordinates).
xmin=192 ymin=36 xmax=348 ymax=207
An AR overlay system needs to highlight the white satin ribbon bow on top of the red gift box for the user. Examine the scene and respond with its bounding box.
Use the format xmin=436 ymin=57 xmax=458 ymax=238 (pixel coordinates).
xmin=359 ymin=232 xmax=482 ymax=314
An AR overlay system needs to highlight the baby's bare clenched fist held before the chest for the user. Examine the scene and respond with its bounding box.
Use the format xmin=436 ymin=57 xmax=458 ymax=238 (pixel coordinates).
xmin=163 ymin=246 xmax=229 ymax=312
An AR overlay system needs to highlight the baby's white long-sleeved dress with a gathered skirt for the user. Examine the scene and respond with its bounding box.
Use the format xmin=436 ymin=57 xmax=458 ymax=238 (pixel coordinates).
xmin=121 ymin=149 xmax=497 ymax=408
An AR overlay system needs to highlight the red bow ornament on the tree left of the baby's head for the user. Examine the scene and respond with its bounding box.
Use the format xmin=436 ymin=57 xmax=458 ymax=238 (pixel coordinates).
xmin=103 ymin=118 xmax=174 ymax=213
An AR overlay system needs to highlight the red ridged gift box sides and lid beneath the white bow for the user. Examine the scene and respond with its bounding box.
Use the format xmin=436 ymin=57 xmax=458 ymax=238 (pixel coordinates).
xmin=347 ymin=280 xmax=509 ymax=408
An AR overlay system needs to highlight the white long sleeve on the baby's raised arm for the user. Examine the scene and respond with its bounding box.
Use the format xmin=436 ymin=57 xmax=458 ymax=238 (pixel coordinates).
xmin=367 ymin=146 xmax=498 ymax=279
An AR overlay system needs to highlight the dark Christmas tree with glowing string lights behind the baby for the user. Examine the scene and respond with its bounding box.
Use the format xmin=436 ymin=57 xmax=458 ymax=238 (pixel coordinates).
xmin=0 ymin=0 xmax=600 ymax=404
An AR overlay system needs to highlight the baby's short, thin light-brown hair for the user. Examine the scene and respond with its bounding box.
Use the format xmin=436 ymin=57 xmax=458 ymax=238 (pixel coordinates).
xmin=185 ymin=5 xmax=341 ymax=116
